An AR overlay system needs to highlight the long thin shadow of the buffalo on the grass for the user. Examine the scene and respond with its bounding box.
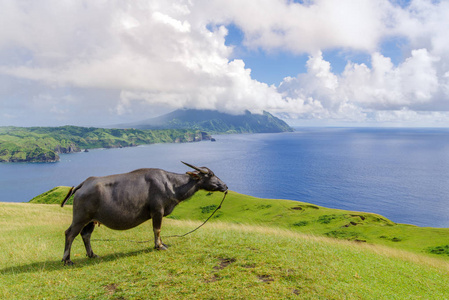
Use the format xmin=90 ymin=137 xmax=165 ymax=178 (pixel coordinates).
xmin=0 ymin=248 xmax=157 ymax=275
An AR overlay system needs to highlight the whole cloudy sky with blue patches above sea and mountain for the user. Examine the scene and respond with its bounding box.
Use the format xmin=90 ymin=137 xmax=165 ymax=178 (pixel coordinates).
xmin=0 ymin=0 xmax=449 ymax=127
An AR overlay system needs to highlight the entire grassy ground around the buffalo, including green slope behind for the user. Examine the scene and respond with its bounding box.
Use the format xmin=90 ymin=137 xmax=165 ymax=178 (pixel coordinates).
xmin=0 ymin=188 xmax=449 ymax=299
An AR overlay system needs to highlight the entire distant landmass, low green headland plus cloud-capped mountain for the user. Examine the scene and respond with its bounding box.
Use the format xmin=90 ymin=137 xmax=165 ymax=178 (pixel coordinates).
xmin=0 ymin=109 xmax=293 ymax=162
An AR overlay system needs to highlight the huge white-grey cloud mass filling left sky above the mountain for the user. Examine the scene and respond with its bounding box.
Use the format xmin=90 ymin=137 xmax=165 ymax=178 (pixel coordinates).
xmin=0 ymin=1 xmax=288 ymax=124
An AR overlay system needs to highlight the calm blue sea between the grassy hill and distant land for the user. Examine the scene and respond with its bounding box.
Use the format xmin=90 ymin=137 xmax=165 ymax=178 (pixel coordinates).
xmin=0 ymin=128 xmax=449 ymax=227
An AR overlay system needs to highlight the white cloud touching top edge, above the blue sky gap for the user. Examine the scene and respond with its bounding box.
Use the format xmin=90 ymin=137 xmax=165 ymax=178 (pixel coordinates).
xmin=201 ymin=0 xmax=391 ymax=53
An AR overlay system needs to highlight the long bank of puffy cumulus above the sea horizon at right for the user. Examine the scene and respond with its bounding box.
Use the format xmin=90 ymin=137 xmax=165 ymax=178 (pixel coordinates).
xmin=278 ymin=49 xmax=449 ymax=122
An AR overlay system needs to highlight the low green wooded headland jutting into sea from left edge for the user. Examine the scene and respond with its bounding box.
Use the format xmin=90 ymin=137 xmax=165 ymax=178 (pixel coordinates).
xmin=0 ymin=126 xmax=210 ymax=162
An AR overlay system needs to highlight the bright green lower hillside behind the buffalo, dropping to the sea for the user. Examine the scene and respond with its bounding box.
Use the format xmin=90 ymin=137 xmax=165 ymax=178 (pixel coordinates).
xmin=30 ymin=187 xmax=449 ymax=260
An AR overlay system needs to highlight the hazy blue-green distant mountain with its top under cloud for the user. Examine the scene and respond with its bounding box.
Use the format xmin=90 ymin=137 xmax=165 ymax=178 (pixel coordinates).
xmin=119 ymin=109 xmax=293 ymax=133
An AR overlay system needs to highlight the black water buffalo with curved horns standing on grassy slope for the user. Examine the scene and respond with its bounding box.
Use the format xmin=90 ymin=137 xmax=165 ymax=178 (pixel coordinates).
xmin=61 ymin=162 xmax=228 ymax=265
